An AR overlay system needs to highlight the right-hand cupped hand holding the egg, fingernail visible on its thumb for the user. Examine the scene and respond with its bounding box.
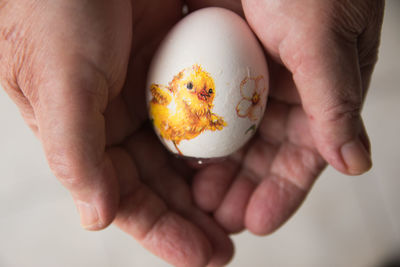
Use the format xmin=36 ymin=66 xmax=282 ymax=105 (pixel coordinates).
xmin=188 ymin=0 xmax=384 ymax=235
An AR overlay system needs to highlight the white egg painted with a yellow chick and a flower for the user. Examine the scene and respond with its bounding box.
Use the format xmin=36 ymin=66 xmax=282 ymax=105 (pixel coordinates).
xmin=147 ymin=8 xmax=269 ymax=158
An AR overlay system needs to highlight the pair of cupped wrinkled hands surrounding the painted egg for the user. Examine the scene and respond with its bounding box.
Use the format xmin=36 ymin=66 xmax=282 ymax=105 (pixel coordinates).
xmin=0 ymin=0 xmax=384 ymax=266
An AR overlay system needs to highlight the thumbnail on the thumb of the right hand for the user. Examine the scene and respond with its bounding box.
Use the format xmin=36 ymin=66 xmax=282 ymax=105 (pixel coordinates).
xmin=341 ymin=139 xmax=372 ymax=175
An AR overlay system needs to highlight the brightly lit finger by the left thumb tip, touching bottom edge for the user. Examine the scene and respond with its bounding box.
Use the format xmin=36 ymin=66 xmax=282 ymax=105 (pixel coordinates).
xmin=115 ymin=184 xmax=211 ymax=267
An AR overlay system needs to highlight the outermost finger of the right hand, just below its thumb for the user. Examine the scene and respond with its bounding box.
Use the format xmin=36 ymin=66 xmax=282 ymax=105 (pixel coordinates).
xmin=244 ymin=143 xmax=324 ymax=235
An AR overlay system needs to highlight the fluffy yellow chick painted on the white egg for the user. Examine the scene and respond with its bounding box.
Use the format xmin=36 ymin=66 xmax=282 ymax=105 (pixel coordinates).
xmin=150 ymin=64 xmax=226 ymax=155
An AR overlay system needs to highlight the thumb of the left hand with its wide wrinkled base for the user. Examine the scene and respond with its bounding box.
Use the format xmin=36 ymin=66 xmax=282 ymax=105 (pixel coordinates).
xmin=0 ymin=1 xmax=131 ymax=230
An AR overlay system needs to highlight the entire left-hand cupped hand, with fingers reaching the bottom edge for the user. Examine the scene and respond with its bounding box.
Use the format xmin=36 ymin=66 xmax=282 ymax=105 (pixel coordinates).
xmin=0 ymin=0 xmax=233 ymax=266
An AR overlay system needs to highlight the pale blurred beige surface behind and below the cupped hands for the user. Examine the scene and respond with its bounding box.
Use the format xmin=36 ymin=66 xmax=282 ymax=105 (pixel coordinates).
xmin=0 ymin=0 xmax=400 ymax=267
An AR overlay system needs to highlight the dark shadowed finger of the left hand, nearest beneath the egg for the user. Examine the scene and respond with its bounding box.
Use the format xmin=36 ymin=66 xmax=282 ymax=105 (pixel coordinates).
xmin=128 ymin=128 xmax=233 ymax=266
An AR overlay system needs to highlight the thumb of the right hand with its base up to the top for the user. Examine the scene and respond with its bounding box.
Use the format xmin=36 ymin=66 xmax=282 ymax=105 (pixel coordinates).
xmin=242 ymin=0 xmax=381 ymax=175
